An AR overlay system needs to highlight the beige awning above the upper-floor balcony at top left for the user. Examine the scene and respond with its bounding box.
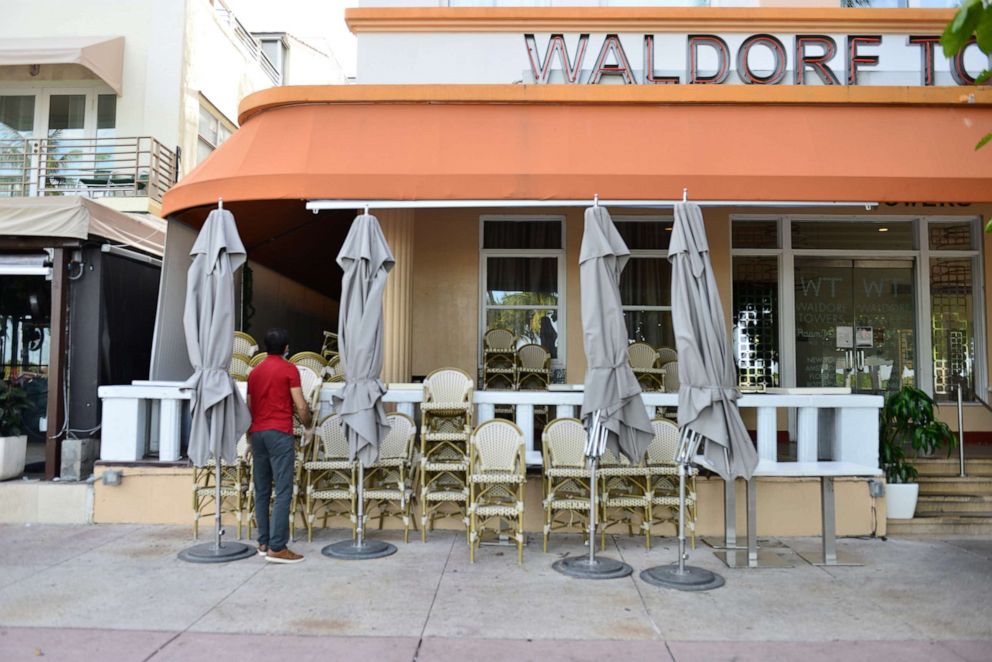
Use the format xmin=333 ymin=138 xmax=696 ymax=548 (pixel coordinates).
xmin=0 ymin=37 xmax=124 ymax=95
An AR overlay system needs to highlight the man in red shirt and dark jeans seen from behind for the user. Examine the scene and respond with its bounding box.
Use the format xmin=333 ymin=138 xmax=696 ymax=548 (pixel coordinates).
xmin=248 ymin=329 xmax=310 ymax=563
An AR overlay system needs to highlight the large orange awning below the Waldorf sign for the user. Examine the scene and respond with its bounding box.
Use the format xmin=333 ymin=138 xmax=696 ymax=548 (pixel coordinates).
xmin=163 ymin=85 xmax=992 ymax=214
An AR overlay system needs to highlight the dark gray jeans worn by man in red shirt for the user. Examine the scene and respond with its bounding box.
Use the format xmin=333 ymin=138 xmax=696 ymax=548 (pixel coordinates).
xmin=251 ymin=430 xmax=296 ymax=552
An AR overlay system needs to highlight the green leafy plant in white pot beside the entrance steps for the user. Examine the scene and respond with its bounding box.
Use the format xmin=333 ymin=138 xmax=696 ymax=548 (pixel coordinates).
xmin=878 ymin=386 xmax=957 ymax=519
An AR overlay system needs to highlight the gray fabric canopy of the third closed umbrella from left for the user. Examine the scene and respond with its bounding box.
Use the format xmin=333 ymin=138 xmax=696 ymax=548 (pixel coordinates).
xmin=579 ymin=206 xmax=654 ymax=462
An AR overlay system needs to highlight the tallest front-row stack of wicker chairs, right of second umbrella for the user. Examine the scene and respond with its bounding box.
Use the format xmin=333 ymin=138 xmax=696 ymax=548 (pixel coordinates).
xmin=419 ymin=368 xmax=474 ymax=541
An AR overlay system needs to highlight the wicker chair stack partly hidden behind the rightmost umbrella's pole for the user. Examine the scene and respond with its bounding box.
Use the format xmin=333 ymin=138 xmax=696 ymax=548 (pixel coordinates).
xmin=646 ymin=418 xmax=699 ymax=549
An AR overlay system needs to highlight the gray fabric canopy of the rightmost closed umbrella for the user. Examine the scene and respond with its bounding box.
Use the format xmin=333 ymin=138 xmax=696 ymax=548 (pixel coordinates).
xmin=668 ymin=203 xmax=758 ymax=480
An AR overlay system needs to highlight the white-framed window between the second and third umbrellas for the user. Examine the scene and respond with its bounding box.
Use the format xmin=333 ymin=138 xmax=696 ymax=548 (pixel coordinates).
xmin=479 ymin=216 xmax=565 ymax=379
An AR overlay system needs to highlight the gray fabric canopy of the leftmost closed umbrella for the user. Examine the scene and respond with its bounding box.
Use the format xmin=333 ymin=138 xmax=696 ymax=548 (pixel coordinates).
xmin=183 ymin=209 xmax=251 ymax=467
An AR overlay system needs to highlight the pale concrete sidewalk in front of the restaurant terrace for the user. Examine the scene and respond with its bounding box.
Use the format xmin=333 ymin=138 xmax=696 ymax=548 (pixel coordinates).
xmin=0 ymin=525 xmax=992 ymax=662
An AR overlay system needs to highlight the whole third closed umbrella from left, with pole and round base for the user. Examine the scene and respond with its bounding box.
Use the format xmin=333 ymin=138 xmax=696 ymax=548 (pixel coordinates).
xmin=554 ymin=204 xmax=654 ymax=579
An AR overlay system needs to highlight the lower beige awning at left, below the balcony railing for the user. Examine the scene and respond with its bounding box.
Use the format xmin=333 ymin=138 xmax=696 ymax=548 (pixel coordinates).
xmin=0 ymin=196 xmax=166 ymax=256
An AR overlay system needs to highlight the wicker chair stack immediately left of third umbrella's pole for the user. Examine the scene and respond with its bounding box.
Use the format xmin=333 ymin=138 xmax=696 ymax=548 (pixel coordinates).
xmin=541 ymin=418 xmax=590 ymax=553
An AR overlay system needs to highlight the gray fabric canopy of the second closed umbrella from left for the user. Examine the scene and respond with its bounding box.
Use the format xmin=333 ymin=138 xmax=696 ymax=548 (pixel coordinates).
xmin=334 ymin=214 xmax=396 ymax=465
